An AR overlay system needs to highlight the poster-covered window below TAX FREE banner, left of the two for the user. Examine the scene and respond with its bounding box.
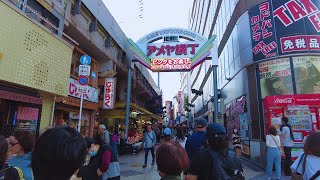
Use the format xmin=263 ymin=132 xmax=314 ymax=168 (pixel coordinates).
xmin=259 ymin=58 xmax=293 ymax=98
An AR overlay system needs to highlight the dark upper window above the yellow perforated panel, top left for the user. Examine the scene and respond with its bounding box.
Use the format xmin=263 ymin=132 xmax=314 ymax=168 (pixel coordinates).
xmin=26 ymin=0 xmax=60 ymax=34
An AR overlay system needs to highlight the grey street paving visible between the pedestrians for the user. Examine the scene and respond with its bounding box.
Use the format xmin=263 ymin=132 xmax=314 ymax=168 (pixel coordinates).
xmin=119 ymin=151 xmax=289 ymax=180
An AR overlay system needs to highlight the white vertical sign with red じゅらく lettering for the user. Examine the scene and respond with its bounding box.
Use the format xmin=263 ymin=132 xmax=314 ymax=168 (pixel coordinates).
xmin=103 ymin=78 xmax=116 ymax=109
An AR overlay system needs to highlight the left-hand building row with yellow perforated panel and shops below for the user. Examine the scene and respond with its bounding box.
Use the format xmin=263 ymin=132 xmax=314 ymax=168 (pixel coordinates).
xmin=0 ymin=0 xmax=162 ymax=136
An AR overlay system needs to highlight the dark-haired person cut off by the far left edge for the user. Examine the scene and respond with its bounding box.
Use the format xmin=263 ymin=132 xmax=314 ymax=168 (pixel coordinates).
xmin=0 ymin=136 xmax=23 ymax=180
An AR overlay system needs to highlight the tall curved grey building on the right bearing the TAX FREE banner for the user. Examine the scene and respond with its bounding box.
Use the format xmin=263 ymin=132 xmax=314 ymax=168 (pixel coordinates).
xmin=189 ymin=0 xmax=320 ymax=166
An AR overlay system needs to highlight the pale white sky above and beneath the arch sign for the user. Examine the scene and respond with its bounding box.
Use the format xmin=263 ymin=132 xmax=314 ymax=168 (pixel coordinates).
xmin=103 ymin=0 xmax=193 ymax=101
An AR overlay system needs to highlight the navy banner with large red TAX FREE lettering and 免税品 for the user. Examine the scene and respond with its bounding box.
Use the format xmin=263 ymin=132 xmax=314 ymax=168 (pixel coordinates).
xmin=249 ymin=0 xmax=320 ymax=61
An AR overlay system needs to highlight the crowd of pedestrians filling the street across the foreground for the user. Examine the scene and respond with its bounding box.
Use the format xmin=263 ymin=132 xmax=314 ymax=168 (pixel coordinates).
xmin=0 ymin=117 xmax=320 ymax=180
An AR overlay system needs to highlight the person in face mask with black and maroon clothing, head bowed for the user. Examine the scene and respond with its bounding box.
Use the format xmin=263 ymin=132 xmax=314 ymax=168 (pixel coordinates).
xmin=77 ymin=138 xmax=120 ymax=180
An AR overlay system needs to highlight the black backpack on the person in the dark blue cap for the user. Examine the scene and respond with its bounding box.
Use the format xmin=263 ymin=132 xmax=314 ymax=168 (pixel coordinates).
xmin=207 ymin=150 xmax=245 ymax=180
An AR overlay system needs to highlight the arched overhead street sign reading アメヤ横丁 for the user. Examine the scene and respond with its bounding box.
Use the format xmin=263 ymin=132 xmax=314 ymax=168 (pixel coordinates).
xmin=128 ymin=28 xmax=218 ymax=72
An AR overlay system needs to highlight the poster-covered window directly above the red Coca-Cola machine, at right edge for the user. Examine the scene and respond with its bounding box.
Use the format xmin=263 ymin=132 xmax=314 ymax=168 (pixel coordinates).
xmin=292 ymin=56 xmax=320 ymax=94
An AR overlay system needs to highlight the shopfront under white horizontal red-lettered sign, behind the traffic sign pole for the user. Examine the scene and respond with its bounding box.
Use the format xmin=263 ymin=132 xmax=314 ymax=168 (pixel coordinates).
xmin=53 ymin=78 xmax=99 ymax=137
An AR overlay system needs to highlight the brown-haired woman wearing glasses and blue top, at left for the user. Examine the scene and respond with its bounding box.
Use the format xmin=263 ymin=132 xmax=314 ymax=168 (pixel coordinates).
xmin=8 ymin=130 xmax=35 ymax=180
